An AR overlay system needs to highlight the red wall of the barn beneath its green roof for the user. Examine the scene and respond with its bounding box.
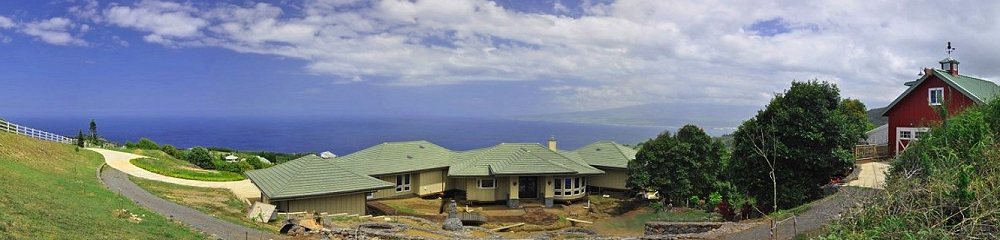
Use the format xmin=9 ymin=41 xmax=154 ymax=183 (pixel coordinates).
xmin=886 ymin=75 xmax=975 ymax=155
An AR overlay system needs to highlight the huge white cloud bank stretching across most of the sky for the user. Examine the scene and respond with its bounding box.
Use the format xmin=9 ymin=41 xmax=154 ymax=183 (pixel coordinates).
xmin=43 ymin=0 xmax=1000 ymax=109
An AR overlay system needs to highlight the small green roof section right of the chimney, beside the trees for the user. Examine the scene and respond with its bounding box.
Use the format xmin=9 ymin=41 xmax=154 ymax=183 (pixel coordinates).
xmin=560 ymin=141 xmax=638 ymax=169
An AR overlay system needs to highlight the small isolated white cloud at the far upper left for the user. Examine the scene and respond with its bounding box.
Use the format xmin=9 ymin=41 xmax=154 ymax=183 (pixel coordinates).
xmin=20 ymin=17 xmax=89 ymax=46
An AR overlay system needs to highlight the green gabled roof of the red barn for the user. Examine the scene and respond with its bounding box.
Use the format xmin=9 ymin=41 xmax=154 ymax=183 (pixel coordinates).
xmin=882 ymin=69 xmax=1000 ymax=116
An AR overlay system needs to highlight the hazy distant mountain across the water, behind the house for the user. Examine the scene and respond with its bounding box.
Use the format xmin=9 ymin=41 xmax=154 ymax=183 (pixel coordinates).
xmin=515 ymin=103 xmax=761 ymax=136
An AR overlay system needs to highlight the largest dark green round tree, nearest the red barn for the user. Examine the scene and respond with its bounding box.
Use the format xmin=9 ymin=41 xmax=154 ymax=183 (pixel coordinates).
xmin=729 ymin=80 xmax=860 ymax=208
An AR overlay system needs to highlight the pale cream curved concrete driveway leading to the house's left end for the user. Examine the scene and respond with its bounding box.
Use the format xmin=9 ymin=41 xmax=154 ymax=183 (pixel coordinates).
xmin=87 ymin=148 xmax=260 ymax=199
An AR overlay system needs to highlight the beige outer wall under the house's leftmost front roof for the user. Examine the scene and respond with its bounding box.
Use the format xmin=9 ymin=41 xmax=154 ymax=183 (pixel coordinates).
xmin=285 ymin=193 xmax=365 ymax=215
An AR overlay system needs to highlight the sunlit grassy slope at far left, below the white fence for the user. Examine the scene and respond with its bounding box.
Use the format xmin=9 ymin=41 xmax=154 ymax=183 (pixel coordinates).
xmin=0 ymin=133 xmax=204 ymax=239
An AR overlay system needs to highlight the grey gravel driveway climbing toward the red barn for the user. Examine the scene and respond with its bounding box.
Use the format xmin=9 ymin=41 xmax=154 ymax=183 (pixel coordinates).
xmin=727 ymin=186 xmax=877 ymax=239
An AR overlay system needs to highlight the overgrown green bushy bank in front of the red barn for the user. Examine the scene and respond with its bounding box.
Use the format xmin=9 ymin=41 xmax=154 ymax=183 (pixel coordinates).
xmin=827 ymin=100 xmax=1000 ymax=239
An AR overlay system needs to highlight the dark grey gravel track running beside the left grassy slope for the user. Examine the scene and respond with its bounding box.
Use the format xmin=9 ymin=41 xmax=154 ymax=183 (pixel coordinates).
xmin=101 ymin=167 xmax=281 ymax=239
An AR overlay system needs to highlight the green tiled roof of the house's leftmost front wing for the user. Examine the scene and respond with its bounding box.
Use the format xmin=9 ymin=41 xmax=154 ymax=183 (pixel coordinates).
xmin=246 ymin=155 xmax=393 ymax=199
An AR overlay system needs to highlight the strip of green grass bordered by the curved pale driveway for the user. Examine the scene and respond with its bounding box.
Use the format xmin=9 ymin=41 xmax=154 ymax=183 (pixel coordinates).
xmin=129 ymin=153 xmax=246 ymax=182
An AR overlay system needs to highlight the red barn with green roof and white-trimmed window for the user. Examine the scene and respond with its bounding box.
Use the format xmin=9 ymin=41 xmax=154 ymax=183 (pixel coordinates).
xmin=882 ymin=57 xmax=1000 ymax=155
